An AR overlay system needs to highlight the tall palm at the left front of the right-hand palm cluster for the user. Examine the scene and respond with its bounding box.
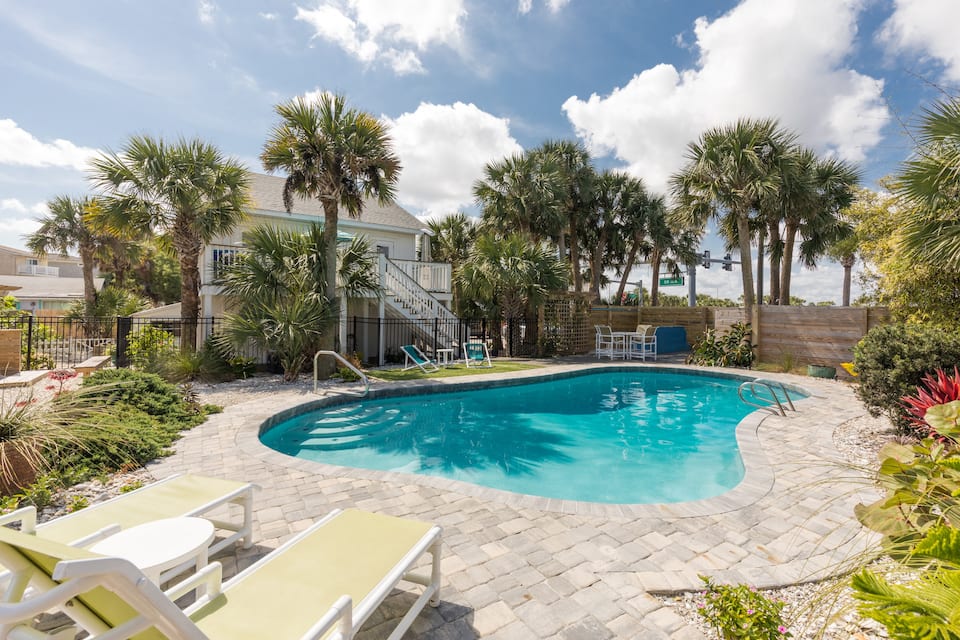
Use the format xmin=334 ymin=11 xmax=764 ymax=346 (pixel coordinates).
xmin=671 ymin=119 xmax=796 ymax=318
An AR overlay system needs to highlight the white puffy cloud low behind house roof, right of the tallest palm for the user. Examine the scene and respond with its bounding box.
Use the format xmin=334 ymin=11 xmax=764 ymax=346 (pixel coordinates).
xmin=384 ymin=102 xmax=523 ymax=216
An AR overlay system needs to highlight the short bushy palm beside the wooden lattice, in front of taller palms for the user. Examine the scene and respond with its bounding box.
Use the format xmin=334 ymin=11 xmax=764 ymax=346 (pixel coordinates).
xmin=457 ymin=233 xmax=567 ymax=355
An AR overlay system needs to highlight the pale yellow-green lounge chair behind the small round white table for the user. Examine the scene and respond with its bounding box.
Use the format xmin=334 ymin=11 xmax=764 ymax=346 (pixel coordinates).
xmin=0 ymin=474 xmax=257 ymax=555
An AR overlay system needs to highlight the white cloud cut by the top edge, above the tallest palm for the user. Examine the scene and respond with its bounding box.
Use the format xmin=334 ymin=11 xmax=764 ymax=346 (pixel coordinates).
xmin=296 ymin=0 xmax=467 ymax=75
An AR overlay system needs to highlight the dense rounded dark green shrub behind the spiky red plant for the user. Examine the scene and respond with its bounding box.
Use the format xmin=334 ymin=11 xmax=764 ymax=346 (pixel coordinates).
xmin=853 ymin=324 xmax=960 ymax=435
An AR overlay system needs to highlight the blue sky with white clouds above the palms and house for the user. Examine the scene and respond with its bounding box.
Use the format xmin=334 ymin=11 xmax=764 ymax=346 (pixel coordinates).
xmin=0 ymin=0 xmax=960 ymax=301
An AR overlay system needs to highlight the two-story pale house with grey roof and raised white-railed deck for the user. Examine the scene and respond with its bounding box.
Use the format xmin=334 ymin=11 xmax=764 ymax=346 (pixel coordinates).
xmin=200 ymin=173 xmax=458 ymax=362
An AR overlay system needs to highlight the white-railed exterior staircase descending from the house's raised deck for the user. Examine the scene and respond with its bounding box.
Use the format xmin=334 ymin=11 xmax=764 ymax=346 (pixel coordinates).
xmin=380 ymin=254 xmax=461 ymax=349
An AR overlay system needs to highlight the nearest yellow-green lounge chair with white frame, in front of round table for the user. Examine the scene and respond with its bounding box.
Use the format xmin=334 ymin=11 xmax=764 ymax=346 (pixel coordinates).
xmin=0 ymin=510 xmax=441 ymax=640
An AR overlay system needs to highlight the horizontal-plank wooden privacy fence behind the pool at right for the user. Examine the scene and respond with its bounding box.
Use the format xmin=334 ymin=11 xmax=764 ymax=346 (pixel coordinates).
xmin=589 ymin=305 xmax=890 ymax=366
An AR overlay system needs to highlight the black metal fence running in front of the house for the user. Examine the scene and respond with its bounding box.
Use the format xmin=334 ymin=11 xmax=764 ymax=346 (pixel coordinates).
xmin=0 ymin=315 xmax=537 ymax=369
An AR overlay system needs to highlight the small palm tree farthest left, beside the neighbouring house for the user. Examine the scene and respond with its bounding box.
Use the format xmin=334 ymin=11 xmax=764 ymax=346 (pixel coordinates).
xmin=26 ymin=196 xmax=106 ymax=317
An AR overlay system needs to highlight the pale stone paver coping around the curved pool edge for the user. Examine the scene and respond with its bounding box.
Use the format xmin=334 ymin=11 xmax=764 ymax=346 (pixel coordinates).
xmin=236 ymin=363 xmax=816 ymax=519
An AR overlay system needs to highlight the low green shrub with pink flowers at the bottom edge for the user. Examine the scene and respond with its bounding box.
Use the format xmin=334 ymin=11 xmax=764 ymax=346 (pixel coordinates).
xmin=698 ymin=576 xmax=792 ymax=640
